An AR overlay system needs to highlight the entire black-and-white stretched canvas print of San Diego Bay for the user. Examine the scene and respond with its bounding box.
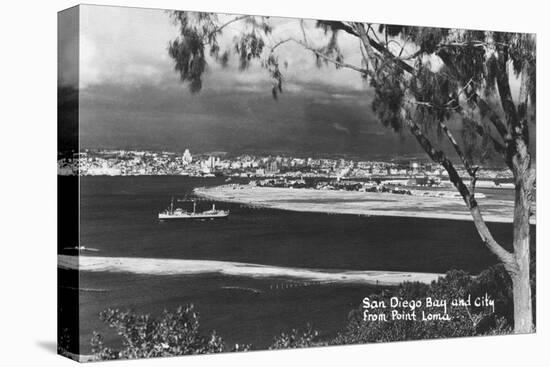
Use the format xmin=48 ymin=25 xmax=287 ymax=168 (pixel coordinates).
xmin=57 ymin=5 xmax=536 ymax=361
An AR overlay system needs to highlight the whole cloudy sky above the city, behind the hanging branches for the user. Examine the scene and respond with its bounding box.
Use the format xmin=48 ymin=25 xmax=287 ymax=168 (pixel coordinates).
xmin=58 ymin=5 xmax=532 ymax=159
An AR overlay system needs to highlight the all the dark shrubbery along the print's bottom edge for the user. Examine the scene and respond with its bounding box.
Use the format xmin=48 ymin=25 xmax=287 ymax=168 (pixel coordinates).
xmin=91 ymin=259 xmax=536 ymax=360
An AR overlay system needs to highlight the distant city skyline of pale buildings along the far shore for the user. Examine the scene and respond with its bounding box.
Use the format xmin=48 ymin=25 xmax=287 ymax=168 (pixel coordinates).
xmin=58 ymin=149 xmax=511 ymax=180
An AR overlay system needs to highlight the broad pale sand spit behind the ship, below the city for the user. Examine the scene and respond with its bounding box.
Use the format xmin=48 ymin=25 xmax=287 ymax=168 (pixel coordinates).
xmin=194 ymin=184 xmax=535 ymax=224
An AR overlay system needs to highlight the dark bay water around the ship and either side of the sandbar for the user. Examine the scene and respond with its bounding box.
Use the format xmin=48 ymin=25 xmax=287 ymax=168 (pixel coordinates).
xmin=64 ymin=176 xmax=536 ymax=353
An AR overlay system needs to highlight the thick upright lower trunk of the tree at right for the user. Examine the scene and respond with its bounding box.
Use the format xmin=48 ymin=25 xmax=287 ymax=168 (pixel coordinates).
xmin=510 ymin=170 xmax=533 ymax=333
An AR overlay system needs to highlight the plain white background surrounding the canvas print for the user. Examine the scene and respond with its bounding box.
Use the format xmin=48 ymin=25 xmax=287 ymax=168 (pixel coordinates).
xmin=0 ymin=0 xmax=550 ymax=367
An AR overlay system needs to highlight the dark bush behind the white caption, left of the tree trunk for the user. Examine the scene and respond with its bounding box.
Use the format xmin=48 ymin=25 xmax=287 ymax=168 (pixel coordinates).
xmin=331 ymin=265 xmax=535 ymax=344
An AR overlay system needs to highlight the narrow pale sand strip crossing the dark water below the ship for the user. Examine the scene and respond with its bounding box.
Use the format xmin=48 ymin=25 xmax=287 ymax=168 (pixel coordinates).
xmin=58 ymin=255 xmax=443 ymax=285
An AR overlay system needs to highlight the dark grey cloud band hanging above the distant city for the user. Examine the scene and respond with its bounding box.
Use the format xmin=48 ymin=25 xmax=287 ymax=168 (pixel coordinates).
xmin=80 ymin=84 xmax=424 ymax=157
